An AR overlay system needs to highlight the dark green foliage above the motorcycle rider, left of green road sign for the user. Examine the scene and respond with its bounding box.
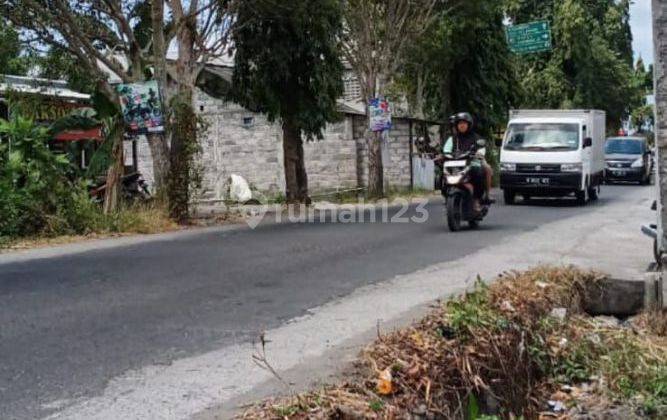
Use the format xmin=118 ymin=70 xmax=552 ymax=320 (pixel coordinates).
xmin=400 ymin=1 xmax=518 ymax=138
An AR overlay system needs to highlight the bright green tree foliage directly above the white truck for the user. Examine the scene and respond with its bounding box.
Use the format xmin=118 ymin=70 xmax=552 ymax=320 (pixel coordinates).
xmin=507 ymin=0 xmax=643 ymax=129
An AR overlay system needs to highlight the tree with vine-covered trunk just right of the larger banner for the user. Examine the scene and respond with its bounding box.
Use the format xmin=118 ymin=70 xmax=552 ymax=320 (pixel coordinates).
xmin=159 ymin=0 xmax=235 ymax=222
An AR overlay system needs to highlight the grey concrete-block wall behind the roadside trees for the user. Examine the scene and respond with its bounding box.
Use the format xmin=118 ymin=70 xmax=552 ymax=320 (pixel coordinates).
xmin=130 ymin=88 xmax=418 ymax=200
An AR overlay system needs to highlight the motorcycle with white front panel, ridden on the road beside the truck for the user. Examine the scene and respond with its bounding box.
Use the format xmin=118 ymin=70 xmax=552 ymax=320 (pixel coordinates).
xmin=442 ymin=139 xmax=490 ymax=232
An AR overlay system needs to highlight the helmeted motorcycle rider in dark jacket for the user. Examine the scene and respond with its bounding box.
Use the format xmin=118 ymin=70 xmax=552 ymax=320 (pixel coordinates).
xmin=442 ymin=112 xmax=493 ymax=212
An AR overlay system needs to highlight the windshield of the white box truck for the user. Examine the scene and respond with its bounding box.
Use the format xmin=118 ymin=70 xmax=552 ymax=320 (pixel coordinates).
xmin=505 ymin=123 xmax=579 ymax=151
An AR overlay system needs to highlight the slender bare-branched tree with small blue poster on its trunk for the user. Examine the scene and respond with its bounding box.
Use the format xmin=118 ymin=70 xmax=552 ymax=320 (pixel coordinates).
xmin=343 ymin=0 xmax=438 ymax=197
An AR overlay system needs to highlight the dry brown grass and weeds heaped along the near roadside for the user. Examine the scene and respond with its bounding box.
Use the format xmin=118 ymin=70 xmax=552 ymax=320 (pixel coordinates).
xmin=239 ymin=267 xmax=667 ymax=419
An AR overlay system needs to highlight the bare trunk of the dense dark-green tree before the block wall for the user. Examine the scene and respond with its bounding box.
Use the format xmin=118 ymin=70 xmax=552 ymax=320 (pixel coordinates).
xmin=283 ymin=121 xmax=310 ymax=204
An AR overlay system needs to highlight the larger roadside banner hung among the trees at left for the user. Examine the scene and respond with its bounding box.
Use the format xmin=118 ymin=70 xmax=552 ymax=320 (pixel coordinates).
xmin=116 ymin=80 xmax=164 ymax=134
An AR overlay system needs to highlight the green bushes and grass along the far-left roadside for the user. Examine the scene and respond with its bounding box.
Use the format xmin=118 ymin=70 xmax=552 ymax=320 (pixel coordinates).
xmin=0 ymin=117 xmax=173 ymax=245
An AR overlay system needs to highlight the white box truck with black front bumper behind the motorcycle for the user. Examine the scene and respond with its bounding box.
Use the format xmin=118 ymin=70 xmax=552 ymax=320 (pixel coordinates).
xmin=500 ymin=110 xmax=606 ymax=205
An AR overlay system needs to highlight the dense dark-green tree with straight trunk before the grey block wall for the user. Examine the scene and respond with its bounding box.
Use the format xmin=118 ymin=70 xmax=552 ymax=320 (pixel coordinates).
xmin=233 ymin=0 xmax=343 ymax=203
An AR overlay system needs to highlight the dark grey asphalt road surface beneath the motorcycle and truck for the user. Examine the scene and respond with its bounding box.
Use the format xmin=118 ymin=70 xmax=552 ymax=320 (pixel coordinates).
xmin=0 ymin=187 xmax=641 ymax=419
